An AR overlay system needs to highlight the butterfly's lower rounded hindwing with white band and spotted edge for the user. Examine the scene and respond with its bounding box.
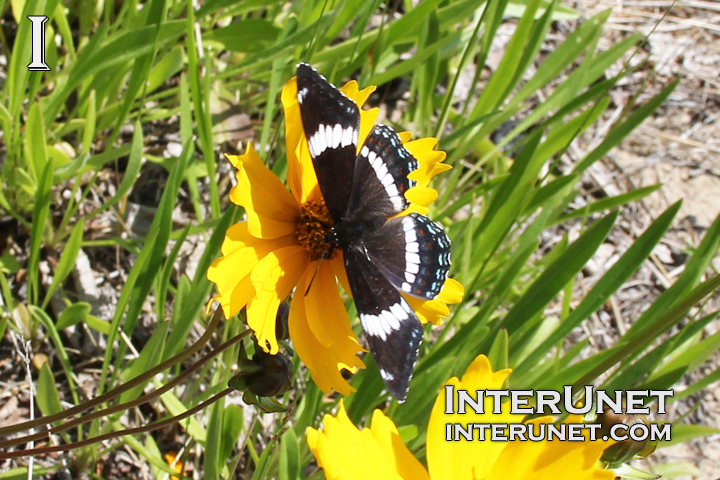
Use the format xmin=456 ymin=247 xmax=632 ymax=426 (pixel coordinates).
xmin=363 ymin=213 xmax=450 ymax=299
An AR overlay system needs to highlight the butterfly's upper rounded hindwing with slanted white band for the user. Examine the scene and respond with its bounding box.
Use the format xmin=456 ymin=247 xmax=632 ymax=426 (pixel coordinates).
xmin=347 ymin=125 xmax=418 ymax=219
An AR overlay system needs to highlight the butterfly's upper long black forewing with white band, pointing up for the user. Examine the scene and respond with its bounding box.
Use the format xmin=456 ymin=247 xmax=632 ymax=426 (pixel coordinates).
xmin=297 ymin=63 xmax=360 ymax=223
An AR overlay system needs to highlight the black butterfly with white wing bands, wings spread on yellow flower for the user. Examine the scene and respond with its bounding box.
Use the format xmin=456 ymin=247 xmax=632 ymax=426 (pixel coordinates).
xmin=297 ymin=63 xmax=450 ymax=402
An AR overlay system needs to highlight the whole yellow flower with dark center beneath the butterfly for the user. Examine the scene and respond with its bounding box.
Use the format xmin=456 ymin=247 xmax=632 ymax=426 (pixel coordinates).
xmin=208 ymin=70 xmax=463 ymax=395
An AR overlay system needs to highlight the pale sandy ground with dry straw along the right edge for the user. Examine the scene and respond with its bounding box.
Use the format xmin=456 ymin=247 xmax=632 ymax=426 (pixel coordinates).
xmin=574 ymin=0 xmax=720 ymax=479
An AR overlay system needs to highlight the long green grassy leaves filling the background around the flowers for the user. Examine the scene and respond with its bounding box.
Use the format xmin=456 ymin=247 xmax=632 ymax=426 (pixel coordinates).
xmin=0 ymin=0 xmax=720 ymax=479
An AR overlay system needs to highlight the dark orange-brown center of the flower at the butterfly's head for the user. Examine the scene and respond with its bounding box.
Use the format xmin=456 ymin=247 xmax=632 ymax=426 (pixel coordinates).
xmin=295 ymin=200 xmax=338 ymax=261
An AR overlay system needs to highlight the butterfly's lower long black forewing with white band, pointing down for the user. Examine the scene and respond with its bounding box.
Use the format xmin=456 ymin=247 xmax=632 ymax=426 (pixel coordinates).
xmin=345 ymin=249 xmax=423 ymax=402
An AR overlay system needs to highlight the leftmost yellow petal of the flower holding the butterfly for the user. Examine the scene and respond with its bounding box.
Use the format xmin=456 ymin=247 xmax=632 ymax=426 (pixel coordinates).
xmin=207 ymin=222 xmax=280 ymax=318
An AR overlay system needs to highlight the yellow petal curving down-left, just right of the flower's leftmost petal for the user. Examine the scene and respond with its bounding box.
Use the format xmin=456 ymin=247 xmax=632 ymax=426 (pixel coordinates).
xmin=247 ymin=242 xmax=310 ymax=354
